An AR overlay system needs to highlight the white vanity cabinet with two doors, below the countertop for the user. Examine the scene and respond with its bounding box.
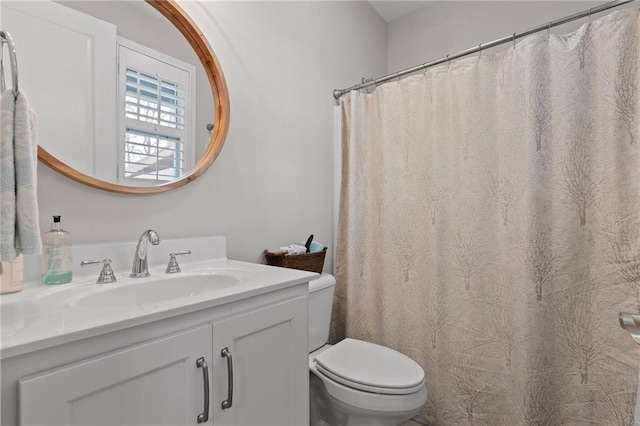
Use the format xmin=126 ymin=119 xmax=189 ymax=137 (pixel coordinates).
xmin=1 ymin=283 xmax=309 ymax=426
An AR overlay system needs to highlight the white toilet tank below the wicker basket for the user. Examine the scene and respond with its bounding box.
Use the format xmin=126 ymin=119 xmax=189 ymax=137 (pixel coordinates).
xmin=309 ymin=274 xmax=336 ymax=353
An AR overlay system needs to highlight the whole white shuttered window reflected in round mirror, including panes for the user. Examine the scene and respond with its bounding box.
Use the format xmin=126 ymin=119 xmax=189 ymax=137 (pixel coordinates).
xmin=117 ymin=38 xmax=195 ymax=185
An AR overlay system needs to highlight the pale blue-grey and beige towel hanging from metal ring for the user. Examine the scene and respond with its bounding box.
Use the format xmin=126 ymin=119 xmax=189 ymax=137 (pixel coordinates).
xmin=0 ymin=90 xmax=42 ymax=261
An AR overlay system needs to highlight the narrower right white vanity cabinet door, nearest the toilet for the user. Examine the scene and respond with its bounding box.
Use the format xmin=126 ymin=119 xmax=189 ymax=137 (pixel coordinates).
xmin=212 ymin=297 xmax=309 ymax=426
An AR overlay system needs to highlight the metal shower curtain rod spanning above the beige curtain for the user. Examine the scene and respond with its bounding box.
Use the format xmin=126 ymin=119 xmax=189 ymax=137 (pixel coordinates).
xmin=333 ymin=0 xmax=636 ymax=99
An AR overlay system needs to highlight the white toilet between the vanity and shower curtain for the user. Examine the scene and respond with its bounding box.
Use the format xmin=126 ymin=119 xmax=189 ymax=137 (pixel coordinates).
xmin=309 ymin=274 xmax=427 ymax=426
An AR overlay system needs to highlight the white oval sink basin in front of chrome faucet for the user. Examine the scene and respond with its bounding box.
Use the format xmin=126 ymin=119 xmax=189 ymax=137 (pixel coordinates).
xmin=34 ymin=273 xmax=240 ymax=308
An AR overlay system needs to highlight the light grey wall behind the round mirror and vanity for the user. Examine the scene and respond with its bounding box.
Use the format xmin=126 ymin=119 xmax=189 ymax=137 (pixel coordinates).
xmin=38 ymin=1 xmax=386 ymax=270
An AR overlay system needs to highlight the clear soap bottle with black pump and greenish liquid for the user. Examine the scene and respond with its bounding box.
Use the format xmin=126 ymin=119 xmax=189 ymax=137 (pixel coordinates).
xmin=42 ymin=216 xmax=73 ymax=285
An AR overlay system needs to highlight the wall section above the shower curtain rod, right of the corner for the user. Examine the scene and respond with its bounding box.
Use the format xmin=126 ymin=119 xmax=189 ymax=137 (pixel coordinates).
xmin=384 ymin=1 xmax=620 ymax=72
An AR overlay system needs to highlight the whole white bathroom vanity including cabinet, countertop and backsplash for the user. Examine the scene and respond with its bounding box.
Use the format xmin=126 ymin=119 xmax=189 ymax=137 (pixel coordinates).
xmin=0 ymin=237 xmax=317 ymax=425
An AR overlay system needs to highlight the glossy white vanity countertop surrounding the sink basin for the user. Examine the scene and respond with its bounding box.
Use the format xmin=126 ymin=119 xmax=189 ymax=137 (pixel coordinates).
xmin=0 ymin=236 xmax=318 ymax=359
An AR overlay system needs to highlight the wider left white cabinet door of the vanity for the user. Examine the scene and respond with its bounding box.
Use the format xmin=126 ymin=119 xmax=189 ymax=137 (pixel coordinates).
xmin=19 ymin=325 xmax=212 ymax=426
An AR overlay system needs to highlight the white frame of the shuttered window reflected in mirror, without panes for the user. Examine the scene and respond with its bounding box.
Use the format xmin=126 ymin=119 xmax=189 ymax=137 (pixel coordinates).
xmin=117 ymin=37 xmax=196 ymax=186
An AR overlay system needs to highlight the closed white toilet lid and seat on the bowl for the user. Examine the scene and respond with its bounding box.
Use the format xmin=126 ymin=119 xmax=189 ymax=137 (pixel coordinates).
xmin=315 ymin=339 xmax=424 ymax=394
